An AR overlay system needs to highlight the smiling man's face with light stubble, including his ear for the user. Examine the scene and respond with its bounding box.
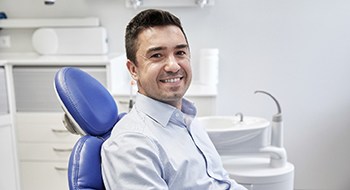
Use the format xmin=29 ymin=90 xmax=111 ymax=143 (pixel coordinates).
xmin=127 ymin=25 xmax=192 ymax=108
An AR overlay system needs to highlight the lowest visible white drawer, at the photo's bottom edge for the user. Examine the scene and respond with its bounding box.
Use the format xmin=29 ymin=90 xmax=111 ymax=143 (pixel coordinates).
xmin=20 ymin=162 xmax=69 ymax=190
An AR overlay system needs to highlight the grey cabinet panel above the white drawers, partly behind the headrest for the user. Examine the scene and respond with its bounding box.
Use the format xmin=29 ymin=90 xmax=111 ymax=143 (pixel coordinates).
xmin=13 ymin=66 xmax=107 ymax=112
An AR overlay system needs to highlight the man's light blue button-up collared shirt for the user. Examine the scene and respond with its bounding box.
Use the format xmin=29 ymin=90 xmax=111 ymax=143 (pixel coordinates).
xmin=101 ymin=94 xmax=245 ymax=190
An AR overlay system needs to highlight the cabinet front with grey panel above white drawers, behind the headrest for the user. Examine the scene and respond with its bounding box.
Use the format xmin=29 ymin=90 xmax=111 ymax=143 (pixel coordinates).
xmin=13 ymin=65 xmax=106 ymax=190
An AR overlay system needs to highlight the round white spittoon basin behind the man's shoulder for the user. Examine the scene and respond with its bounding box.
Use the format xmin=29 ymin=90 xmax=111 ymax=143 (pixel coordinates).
xmin=198 ymin=116 xmax=270 ymax=155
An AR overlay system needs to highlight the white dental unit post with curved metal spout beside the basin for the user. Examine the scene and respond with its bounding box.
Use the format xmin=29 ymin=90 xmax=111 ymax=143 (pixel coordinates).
xmin=255 ymin=90 xmax=287 ymax=168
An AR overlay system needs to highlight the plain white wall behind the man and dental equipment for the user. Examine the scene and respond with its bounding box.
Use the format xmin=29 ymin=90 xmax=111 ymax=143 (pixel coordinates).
xmin=0 ymin=0 xmax=350 ymax=190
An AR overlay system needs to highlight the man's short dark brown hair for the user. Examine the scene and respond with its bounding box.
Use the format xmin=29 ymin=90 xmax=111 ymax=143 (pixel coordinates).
xmin=125 ymin=9 xmax=188 ymax=64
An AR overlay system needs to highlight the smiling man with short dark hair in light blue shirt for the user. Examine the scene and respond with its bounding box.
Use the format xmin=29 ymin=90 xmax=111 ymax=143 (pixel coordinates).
xmin=101 ymin=9 xmax=245 ymax=190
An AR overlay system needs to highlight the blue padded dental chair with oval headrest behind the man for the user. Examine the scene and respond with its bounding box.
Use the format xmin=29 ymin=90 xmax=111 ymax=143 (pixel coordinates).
xmin=54 ymin=67 xmax=124 ymax=190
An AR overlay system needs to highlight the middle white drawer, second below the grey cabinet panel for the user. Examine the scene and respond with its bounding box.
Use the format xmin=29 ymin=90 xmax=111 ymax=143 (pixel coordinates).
xmin=19 ymin=143 xmax=74 ymax=161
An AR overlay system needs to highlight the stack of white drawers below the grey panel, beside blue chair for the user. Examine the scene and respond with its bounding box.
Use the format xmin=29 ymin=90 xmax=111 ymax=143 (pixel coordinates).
xmin=16 ymin=112 xmax=79 ymax=190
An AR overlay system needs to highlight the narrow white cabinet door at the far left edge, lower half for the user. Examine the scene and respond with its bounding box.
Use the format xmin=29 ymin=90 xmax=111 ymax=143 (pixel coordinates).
xmin=0 ymin=115 xmax=16 ymax=190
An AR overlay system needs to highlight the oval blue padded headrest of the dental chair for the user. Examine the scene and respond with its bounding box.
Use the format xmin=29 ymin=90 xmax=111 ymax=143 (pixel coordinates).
xmin=54 ymin=67 xmax=119 ymax=136
